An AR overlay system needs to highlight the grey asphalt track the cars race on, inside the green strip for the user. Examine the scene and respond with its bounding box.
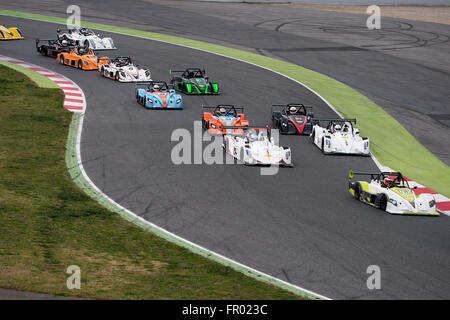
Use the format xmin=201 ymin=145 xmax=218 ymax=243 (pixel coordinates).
xmin=0 ymin=10 xmax=450 ymax=299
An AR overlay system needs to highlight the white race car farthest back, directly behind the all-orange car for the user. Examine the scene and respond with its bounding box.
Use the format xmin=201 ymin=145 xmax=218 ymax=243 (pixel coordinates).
xmin=56 ymin=28 xmax=116 ymax=50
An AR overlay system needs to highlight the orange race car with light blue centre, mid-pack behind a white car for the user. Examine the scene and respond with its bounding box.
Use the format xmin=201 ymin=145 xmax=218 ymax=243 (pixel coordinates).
xmin=202 ymin=104 xmax=249 ymax=134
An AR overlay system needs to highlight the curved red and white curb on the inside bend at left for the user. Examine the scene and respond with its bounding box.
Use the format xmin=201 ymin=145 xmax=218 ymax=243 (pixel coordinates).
xmin=0 ymin=55 xmax=86 ymax=113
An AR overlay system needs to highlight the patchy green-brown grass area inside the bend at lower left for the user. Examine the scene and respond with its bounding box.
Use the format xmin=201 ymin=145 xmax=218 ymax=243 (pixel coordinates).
xmin=0 ymin=66 xmax=300 ymax=299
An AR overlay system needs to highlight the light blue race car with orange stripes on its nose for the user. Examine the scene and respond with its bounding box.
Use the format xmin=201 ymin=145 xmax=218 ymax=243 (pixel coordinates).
xmin=136 ymin=81 xmax=183 ymax=110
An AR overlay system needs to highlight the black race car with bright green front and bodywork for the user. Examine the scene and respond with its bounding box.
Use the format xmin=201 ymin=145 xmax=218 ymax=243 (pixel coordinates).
xmin=169 ymin=68 xmax=220 ymax=95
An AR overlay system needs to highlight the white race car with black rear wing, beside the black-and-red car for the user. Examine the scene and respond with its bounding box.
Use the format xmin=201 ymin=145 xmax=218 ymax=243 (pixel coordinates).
xmin=310 ymin=118 xmax=370 ymax=156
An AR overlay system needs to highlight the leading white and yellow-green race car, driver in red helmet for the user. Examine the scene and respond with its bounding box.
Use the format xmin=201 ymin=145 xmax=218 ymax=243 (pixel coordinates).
xmin=349 ymin=170 xmax=439 ymax=216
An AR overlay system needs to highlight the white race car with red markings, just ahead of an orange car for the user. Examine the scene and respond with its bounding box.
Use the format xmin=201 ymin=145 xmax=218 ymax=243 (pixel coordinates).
xmin=222 ymin=126 xmax=293 ymax=167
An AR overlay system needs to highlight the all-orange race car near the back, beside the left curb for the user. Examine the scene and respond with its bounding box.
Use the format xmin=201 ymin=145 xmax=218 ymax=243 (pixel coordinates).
xmin=56 ymin=47 xmax=109 ymax=70
